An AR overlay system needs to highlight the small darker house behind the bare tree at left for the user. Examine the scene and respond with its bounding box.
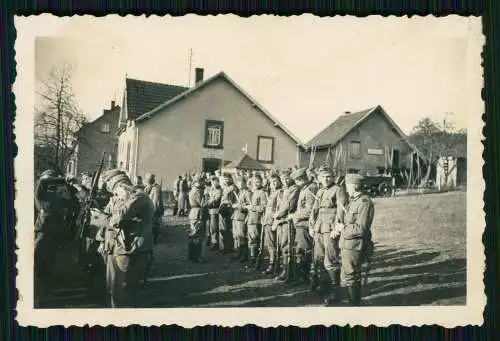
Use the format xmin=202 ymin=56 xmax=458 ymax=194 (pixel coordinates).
xmin=66 ymin=101 xmax=120 ymax=177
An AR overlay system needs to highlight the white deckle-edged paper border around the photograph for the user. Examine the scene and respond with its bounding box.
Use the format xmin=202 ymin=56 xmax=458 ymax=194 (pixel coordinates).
xmin=13 ymin=14 xmax=486 ymax=328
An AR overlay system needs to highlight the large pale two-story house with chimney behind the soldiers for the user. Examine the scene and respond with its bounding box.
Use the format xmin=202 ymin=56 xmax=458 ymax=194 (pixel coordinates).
xmin=118 ymin=68 xmax=303 ymax=184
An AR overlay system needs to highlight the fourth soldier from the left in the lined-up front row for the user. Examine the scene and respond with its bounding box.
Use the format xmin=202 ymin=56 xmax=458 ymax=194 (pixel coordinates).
xmin=232 ymin=177 xmax=252 ymax=263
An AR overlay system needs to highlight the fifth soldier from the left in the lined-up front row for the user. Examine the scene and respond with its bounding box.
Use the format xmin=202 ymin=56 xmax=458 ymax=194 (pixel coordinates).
xmin=247 ymin=174 xmax=267 ymax=263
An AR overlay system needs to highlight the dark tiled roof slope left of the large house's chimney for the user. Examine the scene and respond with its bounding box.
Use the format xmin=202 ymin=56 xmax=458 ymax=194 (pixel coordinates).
xmin=125 ymin=78 xmax=188 ymax=120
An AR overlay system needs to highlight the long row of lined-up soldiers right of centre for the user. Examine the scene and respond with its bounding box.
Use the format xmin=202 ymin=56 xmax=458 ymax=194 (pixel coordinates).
xmin=188 ymin=167 xmax=374 ymax=306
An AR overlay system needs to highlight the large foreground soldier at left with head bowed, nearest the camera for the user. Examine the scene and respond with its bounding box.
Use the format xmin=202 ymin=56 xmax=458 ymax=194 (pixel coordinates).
xmin=101 ymin=170 xmax=155 ymax=308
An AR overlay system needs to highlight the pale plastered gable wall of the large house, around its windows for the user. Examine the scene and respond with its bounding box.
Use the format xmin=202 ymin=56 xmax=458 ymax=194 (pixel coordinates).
xmin=133 ymin=79 xmax=297 ymax=186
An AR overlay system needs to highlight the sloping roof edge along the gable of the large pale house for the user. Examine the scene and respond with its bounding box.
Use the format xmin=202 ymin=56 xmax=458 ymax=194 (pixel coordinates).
xmin=136 ymin=71 xmax=305 ymax=148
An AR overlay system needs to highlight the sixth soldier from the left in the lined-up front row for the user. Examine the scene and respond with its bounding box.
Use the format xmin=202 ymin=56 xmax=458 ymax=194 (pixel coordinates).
xmin=262 ymin=174 xmax=283 ymax=275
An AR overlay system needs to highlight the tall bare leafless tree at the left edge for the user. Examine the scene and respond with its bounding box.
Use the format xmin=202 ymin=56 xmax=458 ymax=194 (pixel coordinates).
xmin=35 ymin=64 xmax=86 ymax=174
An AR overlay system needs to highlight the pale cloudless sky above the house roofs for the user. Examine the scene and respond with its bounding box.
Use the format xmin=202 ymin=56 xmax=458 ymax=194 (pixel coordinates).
xmin=30 ymin=15 xmax=483 ymax=142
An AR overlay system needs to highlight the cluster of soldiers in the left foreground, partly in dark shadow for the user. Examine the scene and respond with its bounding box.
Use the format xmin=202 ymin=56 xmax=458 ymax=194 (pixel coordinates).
xmin=34 ymin=169 xmax=164 ymax=308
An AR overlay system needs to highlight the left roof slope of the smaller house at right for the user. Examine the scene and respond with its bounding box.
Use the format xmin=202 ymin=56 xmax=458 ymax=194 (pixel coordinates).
xmin=307 ymin=107 xmax=378 ymax=147
